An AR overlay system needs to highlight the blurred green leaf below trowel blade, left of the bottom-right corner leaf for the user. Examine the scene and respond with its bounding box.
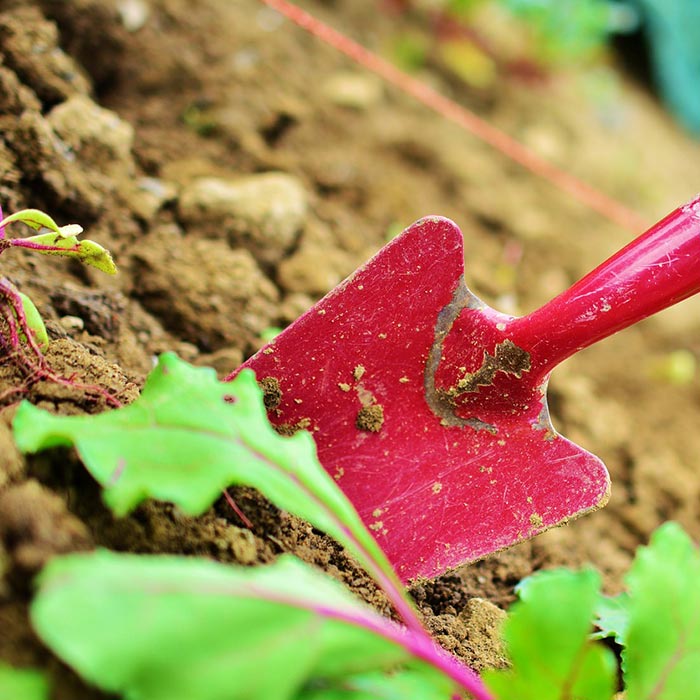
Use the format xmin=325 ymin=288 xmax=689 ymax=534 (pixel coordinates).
xmin=483 ymin=569 xmax=616 ymax=700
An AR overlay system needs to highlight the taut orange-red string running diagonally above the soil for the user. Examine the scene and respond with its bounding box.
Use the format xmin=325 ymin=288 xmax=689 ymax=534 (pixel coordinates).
xmin=261 ymin=0 xmax=648 ymax=233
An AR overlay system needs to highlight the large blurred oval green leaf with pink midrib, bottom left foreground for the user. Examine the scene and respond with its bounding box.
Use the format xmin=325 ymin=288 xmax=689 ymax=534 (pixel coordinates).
xmin=31 ymin=550 xmax=450 ymax=700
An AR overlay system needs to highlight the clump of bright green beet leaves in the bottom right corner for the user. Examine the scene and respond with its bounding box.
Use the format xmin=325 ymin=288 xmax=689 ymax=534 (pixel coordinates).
xmin=484 ymin=522 xmax=700 ymax=700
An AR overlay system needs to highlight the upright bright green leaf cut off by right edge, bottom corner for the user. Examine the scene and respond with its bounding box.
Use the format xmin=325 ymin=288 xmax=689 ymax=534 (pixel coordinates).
xmin=623 ymin=523 xmax=700 ymax=700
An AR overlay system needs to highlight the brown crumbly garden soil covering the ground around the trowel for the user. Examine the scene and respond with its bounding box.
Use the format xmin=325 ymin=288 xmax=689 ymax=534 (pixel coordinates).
xmin=0 ymin=0 xmax=700 ymax=700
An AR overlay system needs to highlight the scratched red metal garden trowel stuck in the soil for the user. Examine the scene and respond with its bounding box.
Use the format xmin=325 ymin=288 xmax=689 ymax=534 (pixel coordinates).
xmin=232 ymin=197 xmax=700 ymax=581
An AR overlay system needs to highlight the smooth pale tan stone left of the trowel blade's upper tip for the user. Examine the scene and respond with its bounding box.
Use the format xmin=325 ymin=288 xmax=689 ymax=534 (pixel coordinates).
xmin=179 ymin=172 xmax=308 ymax=265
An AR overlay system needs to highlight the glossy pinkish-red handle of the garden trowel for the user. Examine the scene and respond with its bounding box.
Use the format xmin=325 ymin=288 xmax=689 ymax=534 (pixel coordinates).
xmin=508 ymin=195 xmax=700 ymax=373
